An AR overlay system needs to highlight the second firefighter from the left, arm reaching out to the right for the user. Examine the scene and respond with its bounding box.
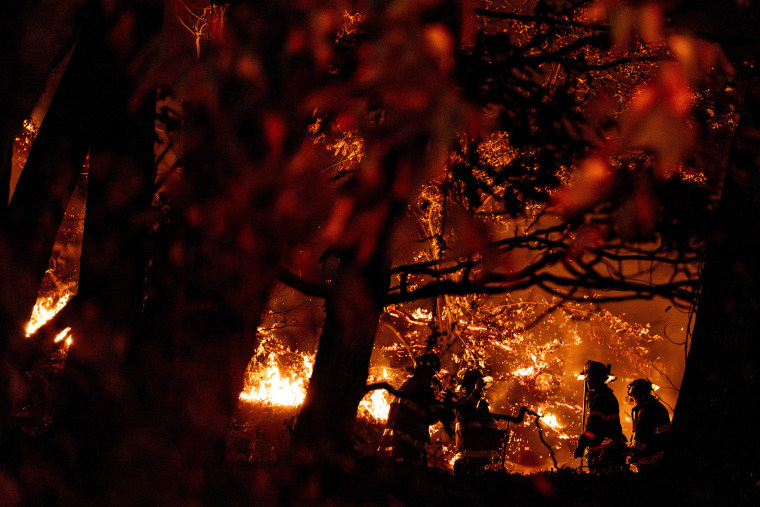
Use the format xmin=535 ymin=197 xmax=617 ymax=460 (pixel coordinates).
xmin=454 ymin=368 xmax=527 ymax=476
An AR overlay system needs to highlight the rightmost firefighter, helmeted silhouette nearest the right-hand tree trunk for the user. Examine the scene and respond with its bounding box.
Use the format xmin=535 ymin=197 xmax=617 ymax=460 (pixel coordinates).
xmin=628 ymin=378 xmax=670 ymax=472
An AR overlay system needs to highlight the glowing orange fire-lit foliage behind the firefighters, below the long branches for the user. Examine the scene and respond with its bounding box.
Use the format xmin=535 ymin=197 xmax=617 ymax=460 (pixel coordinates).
xmin=380 ymin=296 xmax=673 ymax=471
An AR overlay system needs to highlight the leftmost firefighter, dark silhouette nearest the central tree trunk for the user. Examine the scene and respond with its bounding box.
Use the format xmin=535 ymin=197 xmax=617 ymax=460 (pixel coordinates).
xmin=378 ymin=353 xmax=441 ymax=466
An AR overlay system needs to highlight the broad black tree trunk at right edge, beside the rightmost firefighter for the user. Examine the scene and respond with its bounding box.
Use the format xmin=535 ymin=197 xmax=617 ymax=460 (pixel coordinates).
xmin=669 ymin=71 xmax=760 ymax=502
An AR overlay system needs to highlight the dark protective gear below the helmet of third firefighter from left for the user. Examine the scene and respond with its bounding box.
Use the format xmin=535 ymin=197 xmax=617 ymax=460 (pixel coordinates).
xmin=578 ymin=384 xmax=628 ymax=471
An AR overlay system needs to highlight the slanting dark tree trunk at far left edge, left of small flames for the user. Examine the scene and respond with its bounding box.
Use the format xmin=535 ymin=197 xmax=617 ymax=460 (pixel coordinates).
xmin=0 ymin=11 xmax=107 ymax=348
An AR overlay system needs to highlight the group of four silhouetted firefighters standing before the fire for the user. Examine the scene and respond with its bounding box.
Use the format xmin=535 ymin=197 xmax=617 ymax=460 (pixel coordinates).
xmin=379 ymin=353 xmax=670 ymax=476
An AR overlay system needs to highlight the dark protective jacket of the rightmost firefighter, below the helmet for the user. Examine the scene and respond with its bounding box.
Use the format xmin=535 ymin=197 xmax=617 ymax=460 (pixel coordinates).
xmin=631 ymin=394 xmax=670 ymax=469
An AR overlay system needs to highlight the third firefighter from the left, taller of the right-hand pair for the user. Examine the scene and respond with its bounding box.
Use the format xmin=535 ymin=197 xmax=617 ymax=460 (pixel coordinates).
xmin=573 ymin=361 xmax=628 ymax=473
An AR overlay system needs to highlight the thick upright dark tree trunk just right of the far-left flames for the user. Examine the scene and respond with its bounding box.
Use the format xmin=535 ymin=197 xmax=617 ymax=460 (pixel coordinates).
xmin=54 ymin=89 xmax=155 ymax=498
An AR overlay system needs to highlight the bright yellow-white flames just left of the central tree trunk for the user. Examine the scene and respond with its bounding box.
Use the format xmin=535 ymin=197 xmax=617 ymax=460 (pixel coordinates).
xmin=240 ymin=339 xmax=314 ymax=407
